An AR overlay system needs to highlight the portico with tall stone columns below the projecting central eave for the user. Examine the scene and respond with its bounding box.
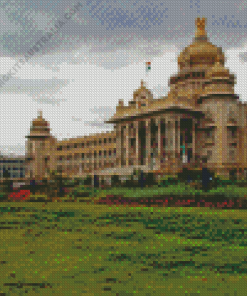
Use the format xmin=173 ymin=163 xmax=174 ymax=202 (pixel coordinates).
xmin=116 ymin=112 xmax=196 ymax=175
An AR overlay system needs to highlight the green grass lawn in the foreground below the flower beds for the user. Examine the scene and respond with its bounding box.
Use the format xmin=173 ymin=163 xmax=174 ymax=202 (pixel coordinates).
xmin=0 ymin=203 xmax=247 ymax=296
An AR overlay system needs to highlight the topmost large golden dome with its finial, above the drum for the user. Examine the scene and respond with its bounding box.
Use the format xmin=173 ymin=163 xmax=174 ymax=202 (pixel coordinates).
xmin=178 ymin=18 xmax=225 ymax=68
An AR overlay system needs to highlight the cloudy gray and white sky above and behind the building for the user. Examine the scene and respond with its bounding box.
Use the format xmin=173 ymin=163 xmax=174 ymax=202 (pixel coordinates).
xmin=0 ymin=0 xmax=247 ymax=155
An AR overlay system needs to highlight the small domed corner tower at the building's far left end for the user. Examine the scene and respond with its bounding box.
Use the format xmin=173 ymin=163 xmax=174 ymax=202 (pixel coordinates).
xmin=26 ymin=111 xmax=56 ymax=180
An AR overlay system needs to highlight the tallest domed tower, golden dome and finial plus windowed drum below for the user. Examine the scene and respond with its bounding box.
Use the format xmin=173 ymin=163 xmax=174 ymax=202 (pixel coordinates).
xmin=169 ymin=18 xmax=228 ymax=105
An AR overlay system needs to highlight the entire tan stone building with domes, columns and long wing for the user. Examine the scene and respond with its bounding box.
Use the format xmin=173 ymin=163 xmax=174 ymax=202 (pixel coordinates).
xmin=26 ymin=18 xmax=247 ymax=182
